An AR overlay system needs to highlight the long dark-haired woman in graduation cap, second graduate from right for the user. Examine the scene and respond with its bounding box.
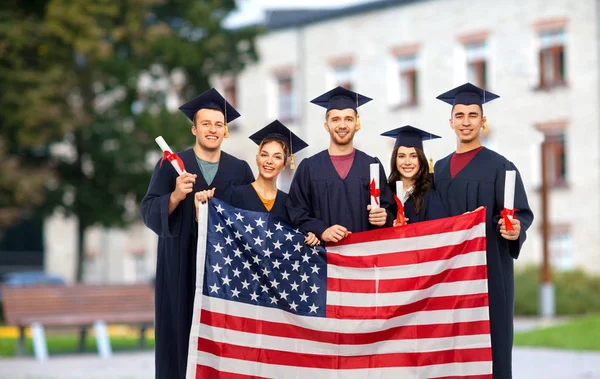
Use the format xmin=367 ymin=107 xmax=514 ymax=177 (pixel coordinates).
xmin=381 ymin=125 xmax=448 ymax=224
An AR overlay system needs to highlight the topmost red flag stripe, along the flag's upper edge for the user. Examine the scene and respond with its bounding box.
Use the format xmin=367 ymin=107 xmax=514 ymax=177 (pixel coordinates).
xmin=327 ymin=207 xmax=485 ymax=246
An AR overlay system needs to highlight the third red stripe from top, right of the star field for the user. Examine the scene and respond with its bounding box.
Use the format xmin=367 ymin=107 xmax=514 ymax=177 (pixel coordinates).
xmin=327 ymin=266 xmax=487 ymax=293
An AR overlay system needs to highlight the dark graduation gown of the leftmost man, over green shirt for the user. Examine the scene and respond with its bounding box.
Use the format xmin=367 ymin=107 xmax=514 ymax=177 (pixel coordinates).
xmin=141 ymin=149 xmax=254 ymax=379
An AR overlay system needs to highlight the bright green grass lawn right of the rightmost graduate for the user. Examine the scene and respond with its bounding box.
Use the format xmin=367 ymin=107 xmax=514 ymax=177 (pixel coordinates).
xmin=515 ymin=314 xmax=600 ymax=350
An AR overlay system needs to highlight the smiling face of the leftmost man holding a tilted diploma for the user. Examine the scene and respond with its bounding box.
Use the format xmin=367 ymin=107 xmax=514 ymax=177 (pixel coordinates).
xmin=192 ymin=108 xmax=225 ymax=151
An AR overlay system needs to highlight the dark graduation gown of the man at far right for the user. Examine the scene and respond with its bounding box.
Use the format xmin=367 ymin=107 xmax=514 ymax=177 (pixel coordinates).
xmin=435 ymin=148 xmax=533 ymax=379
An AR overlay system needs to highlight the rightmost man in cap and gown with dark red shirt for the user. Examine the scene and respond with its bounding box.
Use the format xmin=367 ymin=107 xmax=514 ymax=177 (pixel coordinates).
xmin=434 ymin=83 xmax=533 ymax=379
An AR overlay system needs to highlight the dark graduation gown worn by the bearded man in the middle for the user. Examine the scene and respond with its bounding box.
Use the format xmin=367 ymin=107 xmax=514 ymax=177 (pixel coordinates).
xmin=286 ymin=150 xmax=396 ymax=238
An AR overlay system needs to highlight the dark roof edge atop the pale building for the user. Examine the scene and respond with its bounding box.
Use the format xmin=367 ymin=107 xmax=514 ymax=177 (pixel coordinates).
xmin=266 ymin=0 xmax=423 ymax=30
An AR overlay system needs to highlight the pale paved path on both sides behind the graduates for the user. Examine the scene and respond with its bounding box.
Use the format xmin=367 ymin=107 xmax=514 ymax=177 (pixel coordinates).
xmin=0 ymin=348 xmax=600 ymax=379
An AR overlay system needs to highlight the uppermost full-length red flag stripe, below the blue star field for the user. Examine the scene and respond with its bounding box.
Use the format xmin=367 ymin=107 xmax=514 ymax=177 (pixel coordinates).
xmin=201 ymin=310 xmax=490 ymax=345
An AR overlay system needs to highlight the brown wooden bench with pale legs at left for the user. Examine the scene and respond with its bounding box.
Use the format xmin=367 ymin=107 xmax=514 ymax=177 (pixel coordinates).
xmin=2 ymin=284 xmax=154 ymax=360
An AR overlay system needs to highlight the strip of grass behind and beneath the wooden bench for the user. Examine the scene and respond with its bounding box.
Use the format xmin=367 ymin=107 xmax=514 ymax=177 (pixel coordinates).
xmin=0 ymin=333 xmax=154 ymax=357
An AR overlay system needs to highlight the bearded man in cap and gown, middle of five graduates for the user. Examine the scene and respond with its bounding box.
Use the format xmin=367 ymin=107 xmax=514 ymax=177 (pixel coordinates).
xmin=286 ymin=87 xmax=396 ymax=242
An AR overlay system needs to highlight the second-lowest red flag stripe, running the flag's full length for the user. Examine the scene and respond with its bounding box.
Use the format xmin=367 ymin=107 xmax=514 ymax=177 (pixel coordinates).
xmin=198 ymin=338 xmax=492 ymax=370
